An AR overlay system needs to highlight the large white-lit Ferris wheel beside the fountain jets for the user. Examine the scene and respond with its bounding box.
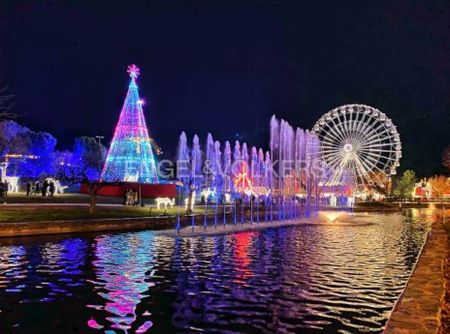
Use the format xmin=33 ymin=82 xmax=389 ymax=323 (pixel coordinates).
xmin=313 ymin=104 xmax=402 ymax=188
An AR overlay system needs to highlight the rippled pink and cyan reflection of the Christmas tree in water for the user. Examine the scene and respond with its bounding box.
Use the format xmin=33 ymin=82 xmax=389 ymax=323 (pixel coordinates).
xmin=88 ymin=233 xmax=158 ymax=333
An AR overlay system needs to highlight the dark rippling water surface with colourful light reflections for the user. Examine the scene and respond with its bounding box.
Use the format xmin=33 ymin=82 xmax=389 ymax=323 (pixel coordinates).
xmin=0 ymin=210 xmax=435 ymax=334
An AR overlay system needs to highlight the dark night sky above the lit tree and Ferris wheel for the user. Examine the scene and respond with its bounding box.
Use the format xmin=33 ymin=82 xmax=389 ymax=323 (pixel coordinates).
xmin=0 ymin=0 xmax=450 ymax=175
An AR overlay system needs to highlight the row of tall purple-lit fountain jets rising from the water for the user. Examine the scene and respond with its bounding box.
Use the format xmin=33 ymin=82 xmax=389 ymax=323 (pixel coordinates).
xmin=177 ymin=116 xmax=342 ymax=234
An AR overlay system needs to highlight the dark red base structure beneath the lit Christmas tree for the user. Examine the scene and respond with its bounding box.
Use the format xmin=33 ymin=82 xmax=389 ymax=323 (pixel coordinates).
xmin=80 ymin=182 xmax=177 ymax=198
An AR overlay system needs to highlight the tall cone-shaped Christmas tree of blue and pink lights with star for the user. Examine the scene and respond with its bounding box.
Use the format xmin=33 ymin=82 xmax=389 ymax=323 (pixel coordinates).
xmin=101 ymin=65 xmax=158 ymax=183
